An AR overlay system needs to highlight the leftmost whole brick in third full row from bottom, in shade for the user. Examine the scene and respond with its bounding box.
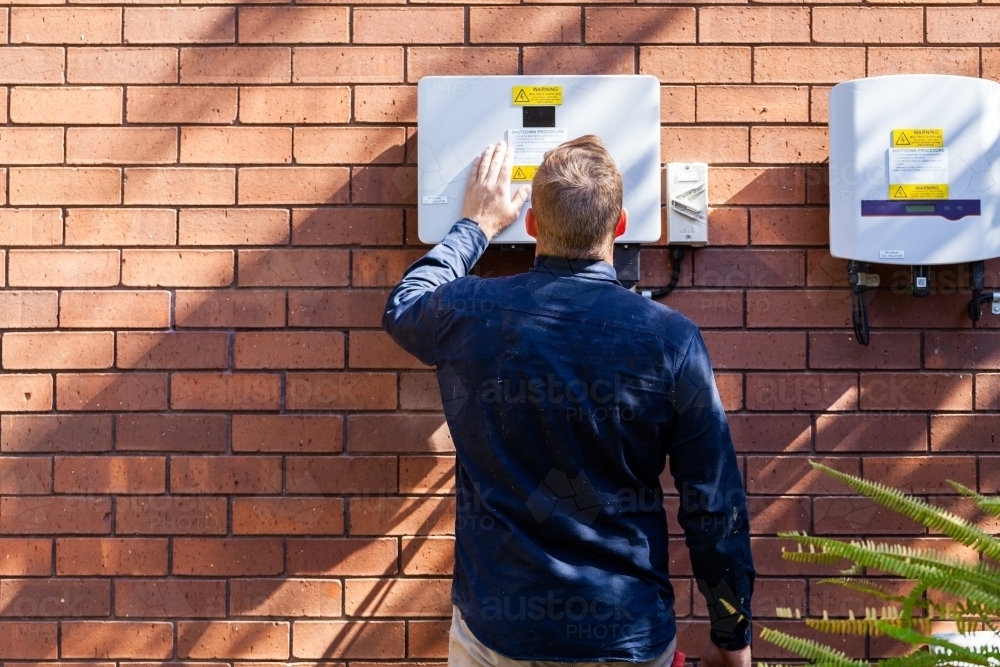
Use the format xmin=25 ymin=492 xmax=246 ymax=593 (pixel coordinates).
xmin=56 ymin=537 xmax=167 ymax=577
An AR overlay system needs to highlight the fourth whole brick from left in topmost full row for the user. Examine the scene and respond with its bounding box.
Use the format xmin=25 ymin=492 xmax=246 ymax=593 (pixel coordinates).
xmin=352 ymin=7 xmax=462 ymax=44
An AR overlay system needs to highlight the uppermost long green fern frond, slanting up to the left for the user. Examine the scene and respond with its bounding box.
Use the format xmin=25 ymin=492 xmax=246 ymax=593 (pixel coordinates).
xmin=809 ymin=461 xmax=1000 ymax=560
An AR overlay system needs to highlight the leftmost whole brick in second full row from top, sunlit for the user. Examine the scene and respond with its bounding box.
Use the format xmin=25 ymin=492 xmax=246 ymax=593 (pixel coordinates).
xmin=66 ymin=47 xmax=179 ymax=83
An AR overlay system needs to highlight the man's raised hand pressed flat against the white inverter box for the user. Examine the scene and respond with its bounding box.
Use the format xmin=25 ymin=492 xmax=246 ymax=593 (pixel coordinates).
xmin=462 ymin=141 xmax=531 ymax=239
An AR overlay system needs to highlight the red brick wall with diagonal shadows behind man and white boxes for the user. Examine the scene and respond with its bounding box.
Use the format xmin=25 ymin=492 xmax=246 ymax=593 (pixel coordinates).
xmin=0 ymin=0 xmax=988 ymax=667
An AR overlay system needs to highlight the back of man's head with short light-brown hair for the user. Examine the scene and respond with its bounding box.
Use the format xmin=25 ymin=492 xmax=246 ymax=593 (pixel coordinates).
xmin=531 ymin=134 xmax=622 ymax=259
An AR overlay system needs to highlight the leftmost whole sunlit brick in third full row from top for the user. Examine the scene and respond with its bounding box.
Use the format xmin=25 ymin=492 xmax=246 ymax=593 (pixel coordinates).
xmin=10 ymin=86 xmax=122 ymax=124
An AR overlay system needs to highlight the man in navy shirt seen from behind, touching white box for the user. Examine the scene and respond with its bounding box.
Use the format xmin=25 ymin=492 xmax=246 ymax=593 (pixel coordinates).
xmin=383 ymin=136 xmax=754 ymax=667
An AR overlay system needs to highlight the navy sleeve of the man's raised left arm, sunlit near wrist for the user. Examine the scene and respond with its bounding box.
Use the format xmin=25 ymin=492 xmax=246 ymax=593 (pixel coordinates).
xmin=382 ymin=218 xmax=489 ymax=365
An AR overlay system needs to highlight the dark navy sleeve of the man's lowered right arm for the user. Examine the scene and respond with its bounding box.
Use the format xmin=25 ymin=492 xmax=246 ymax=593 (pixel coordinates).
xmin=667 ymin=330 xmax=755 ymax=651
